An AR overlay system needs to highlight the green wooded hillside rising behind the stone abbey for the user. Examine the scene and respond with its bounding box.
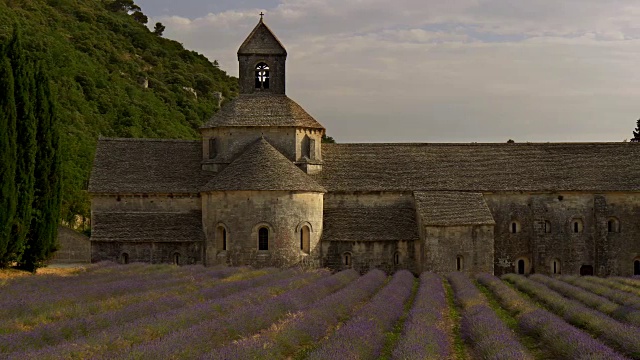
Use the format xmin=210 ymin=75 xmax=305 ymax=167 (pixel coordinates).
xmin=0 ymin=0 xmax=238 ymax=226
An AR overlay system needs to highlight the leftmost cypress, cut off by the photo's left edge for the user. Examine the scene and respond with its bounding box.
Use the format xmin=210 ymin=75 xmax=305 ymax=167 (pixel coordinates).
xmin=0 ymin=55 xmax=17 ymax=267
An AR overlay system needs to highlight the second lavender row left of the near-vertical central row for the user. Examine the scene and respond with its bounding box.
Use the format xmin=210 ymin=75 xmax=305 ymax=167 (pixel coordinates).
xmin=202 ymin=270 xmax=387 ymax=359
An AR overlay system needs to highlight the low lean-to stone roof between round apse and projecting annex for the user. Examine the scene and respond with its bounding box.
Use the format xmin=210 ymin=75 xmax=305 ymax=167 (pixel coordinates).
xmin=322 ymin=205 xmax=418 ymax=241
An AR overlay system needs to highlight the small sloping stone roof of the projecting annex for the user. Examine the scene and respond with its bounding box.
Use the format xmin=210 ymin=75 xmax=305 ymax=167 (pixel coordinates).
xmin=413 ymin=191 xmax=495 ymax=226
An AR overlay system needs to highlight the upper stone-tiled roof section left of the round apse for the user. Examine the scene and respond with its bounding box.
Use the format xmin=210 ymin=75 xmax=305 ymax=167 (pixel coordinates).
xmin=89 ymin=139 xmax=212 ymax=193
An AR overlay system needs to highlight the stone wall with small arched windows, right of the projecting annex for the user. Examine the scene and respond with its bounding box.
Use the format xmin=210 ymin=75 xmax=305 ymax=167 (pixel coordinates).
xmin=485 ymin=192 xmax=640 ymax=276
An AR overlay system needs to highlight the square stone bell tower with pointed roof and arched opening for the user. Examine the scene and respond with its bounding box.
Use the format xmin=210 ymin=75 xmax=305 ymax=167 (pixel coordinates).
xmin=238 ymin=13 xmax=287 ymax=95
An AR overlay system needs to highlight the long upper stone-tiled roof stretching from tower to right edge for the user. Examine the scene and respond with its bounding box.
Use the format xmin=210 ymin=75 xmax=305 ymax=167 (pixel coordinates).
xmin=316 ymin=143 xmax=640 ymax=192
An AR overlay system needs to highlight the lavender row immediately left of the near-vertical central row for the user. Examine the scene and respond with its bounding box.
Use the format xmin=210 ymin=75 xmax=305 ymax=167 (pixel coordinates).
xmin=308 ymin=270 xmax=415 ymax=360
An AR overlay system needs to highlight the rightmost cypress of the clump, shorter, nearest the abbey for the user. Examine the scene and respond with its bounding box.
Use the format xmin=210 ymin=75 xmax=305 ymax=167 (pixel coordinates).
xmin=20 ymin=66 xmax=61 ymax=271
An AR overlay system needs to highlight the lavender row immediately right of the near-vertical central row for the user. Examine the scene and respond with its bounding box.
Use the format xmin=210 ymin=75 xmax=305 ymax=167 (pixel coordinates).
xmin=447 ymin=272 xmax=532 ymax=359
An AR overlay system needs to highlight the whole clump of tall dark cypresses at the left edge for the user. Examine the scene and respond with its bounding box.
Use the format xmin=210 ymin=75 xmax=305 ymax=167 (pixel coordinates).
xmin=0 ymin=28 xmax=61 ymax=271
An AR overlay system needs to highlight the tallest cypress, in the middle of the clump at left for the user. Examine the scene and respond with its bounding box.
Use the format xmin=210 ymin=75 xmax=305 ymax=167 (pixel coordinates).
xmin=6 ymin=28 xmax=37 ymax=260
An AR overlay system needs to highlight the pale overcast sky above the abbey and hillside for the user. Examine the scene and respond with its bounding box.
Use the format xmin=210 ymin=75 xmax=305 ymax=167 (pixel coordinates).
xmin=136 ymin=0 xmax=640 ymax=142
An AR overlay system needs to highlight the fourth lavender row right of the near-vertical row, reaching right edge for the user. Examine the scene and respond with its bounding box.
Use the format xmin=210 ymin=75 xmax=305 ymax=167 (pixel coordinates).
xmin=530 ymin=274 xmax=640 ymax=326
